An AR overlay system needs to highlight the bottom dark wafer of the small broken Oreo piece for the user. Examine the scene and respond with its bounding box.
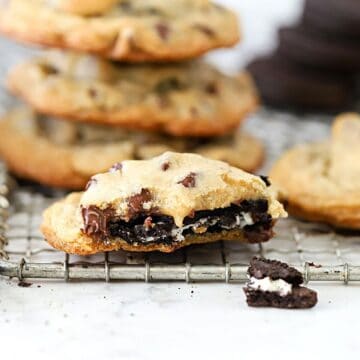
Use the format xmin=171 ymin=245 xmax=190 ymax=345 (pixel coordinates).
xmin=244 ymin=286 xmax=317 ymax=309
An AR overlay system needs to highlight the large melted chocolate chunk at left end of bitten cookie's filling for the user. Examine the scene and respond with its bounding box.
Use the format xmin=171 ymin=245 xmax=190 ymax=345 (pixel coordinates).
xmin=81 ymin=205 xmax=115 ymax=239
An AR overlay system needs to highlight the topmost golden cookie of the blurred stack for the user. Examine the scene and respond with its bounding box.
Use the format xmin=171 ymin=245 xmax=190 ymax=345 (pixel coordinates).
xmin=0 ymin=0 xmax=240 ymax=61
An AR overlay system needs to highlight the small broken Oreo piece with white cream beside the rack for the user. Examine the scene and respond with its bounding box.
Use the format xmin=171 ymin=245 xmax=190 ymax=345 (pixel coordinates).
xmin=244 ymin=257 xmax=317 ymax=309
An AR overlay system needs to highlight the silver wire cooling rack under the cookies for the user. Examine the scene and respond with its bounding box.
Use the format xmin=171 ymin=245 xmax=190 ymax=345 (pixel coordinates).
xmin=0 ymin=40 xmax=360 ymax=284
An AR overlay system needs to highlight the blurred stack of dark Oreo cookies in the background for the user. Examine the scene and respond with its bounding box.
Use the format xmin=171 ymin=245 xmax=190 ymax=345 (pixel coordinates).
xmin=248 ymin=0 xmax=360 ymax=112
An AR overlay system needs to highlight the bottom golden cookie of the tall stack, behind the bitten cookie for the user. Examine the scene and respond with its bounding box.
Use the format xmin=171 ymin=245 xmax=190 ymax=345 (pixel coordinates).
xmin=0 ymin=108 xmax=264 ymax=190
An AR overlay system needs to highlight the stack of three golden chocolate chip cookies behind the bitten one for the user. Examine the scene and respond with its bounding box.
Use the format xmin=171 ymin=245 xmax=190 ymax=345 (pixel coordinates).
xmin=0 ymin=0 xmax=263 ymax=189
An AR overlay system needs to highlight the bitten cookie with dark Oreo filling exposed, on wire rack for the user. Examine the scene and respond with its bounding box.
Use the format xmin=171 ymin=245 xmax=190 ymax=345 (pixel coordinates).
xmin=42 ymin=152 xmax=286 ymax=255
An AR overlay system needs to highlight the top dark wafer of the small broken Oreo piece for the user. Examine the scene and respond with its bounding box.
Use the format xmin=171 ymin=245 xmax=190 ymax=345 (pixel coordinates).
xmin=248 ymin=257 xmax=304 ymax=285
